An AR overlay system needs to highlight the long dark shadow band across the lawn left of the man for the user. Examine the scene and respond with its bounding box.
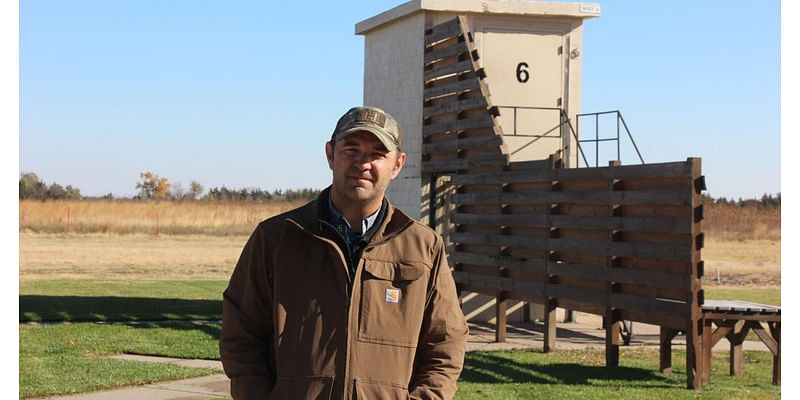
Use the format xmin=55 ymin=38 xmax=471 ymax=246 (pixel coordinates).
xmin=19 ymin=295 xmax=222 ymax=322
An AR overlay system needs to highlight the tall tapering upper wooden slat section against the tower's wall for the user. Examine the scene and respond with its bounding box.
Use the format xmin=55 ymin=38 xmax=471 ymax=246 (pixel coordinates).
xmin=422 ymin=16 xmax=508 ymax=174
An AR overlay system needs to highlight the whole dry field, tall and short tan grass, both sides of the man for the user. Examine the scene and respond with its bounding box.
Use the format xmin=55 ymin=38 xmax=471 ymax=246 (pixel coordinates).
xmin=19 ymin=201 xmax=781 ymax=286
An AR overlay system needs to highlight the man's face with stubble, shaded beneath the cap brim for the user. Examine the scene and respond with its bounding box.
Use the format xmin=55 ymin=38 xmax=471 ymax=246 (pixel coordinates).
xmin=325 ymin=132 xmax=406 ymax=203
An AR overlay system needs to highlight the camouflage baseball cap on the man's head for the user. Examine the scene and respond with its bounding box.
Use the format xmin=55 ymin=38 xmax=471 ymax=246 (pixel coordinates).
xmin=331 ymin=107 xmax=402 ymax=151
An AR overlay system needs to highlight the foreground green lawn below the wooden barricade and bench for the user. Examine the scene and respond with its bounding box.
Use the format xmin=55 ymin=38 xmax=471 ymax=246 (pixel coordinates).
xmin=456 ymin=348 xmax=781 ymax=400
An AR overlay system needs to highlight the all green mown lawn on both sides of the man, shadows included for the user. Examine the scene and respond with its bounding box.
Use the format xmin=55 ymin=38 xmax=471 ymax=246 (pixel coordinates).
xmin=19 ymin=281 xmax=780 ymax=400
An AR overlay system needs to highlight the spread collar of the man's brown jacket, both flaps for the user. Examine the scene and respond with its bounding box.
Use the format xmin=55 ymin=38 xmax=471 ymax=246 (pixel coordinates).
xmin=287 ymin=186 xmax=413 ymax=243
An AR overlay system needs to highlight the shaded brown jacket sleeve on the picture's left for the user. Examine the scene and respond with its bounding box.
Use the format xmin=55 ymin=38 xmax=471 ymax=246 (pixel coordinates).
xmin=219 ymin=226 xmax=275 ymax=400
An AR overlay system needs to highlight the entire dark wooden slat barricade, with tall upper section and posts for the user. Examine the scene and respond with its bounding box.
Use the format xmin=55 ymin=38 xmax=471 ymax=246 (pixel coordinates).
xmin=422 ymin=17 xmax=704 ymax=388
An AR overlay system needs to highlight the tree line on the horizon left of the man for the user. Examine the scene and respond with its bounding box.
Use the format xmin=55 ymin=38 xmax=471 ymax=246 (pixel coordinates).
xmin=19 ymin=171 xmax=321 ymax=202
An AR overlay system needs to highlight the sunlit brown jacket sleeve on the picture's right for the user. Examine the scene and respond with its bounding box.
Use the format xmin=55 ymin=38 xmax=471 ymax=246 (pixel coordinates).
xmin=409 ymin=237 xmax=469 ymax=399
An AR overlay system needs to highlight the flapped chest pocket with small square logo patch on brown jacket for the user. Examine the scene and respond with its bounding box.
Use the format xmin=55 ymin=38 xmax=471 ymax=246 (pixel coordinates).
xmin=358 ymin=260 xmax=430 ymax=347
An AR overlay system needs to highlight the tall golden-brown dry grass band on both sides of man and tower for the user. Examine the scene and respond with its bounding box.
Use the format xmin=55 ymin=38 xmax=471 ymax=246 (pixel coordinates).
xmin=19 ymin=200 xmax=781 ymax=240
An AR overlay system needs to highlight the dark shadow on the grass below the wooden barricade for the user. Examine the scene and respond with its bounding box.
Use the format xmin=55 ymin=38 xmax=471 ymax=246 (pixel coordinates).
xmin=460 ymin=353 xmax=675 ymax=387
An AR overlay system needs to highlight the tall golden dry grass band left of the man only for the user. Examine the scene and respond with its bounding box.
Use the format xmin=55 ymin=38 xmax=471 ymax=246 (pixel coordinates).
xmin=19 ymin=200 xmax=302 ymax=236
